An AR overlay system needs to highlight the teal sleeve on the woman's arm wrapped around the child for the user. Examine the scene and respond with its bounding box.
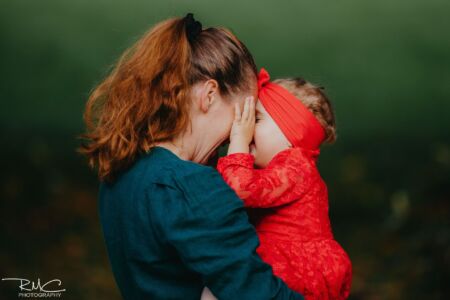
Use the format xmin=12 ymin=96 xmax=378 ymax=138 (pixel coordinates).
xmin=149 ymin=167 xmax=303 ymax=299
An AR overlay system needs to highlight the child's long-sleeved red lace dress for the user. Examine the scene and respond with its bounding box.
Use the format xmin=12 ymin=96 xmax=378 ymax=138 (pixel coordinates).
xmin=217 ymin=148 xmax=352 ymax=299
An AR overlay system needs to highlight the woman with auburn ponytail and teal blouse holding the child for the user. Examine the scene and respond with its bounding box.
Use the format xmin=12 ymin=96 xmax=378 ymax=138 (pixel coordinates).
xmin=82 ymin=14 xmax=302 ymax=299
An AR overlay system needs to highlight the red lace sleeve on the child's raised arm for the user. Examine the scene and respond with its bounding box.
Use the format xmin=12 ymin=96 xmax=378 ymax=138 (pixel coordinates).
xmin=217 ymin=148 xmax=310 ymax=208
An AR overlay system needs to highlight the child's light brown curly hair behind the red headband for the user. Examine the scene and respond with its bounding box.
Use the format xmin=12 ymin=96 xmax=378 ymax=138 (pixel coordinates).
xmin=273 ymin=77 xmax=336 ymax=144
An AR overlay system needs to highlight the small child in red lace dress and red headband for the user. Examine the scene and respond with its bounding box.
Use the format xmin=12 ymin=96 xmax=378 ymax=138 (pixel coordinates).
xmin=217 ymin=69 xmax=352 ymax=299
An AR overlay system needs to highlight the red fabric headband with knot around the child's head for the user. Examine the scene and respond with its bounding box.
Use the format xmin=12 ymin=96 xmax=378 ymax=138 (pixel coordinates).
xmin=258 ymin=68 xmax=325 ymax=150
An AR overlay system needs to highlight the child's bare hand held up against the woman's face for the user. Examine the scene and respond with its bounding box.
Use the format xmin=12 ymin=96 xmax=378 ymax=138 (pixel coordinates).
xmin=228 ymin=97 xmax=255 ymax=154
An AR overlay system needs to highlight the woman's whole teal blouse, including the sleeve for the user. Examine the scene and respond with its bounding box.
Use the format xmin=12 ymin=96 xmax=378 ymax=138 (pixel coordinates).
xmin=99 ymin=147 xmax=303 ymax=300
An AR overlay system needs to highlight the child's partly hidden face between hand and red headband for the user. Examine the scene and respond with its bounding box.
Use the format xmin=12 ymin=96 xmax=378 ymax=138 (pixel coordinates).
xmin=250 ymin=101 xmax=290 ymax=168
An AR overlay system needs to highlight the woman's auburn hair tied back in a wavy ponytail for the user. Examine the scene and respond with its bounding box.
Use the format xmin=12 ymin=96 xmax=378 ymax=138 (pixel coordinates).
xmin=79 ymin=14 xmax=256 ymax=181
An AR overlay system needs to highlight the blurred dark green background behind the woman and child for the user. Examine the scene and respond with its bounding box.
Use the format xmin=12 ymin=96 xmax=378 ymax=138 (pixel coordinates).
xmin=0 ymin=0 xmax=450 ymax=299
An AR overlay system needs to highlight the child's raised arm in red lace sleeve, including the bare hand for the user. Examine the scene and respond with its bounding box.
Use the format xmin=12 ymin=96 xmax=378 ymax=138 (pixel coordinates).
xmin=217 ymin=97 xmax=312 ymax=207
